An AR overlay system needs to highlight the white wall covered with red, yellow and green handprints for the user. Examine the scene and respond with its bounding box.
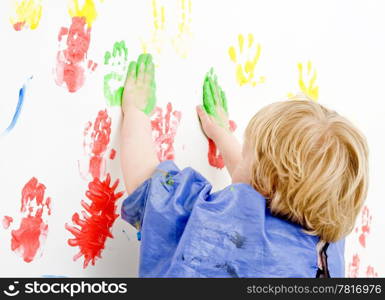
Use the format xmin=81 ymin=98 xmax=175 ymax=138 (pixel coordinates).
xmin=0 ymin=0 xmax=385 ymax=276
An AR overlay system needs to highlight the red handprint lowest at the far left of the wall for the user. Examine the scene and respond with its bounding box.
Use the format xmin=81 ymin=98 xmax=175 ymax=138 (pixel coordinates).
xmin=11 ymin=177 xmax=51 ymax=262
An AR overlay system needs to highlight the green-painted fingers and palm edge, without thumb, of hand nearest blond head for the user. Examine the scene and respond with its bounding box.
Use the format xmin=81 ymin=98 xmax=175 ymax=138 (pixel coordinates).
xmin=203 ymin=68 xmax=228 ymax=127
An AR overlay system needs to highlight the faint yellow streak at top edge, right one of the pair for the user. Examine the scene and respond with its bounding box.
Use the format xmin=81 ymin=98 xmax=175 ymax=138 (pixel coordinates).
xmin=172 ymin=0 xmax=193 ymax=58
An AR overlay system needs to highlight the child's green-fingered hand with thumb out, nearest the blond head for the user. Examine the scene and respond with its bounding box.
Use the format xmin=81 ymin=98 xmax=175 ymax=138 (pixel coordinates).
xmin=197 ymin=69 xmax=230 ymax=141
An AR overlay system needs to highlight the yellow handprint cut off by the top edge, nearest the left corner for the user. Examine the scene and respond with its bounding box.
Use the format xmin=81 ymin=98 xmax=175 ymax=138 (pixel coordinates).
xmin=10 ymin=0 xmax=42 ymax=31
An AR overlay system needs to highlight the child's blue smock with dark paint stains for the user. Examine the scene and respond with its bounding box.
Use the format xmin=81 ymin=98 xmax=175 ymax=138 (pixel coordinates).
xmin=121 ymin=161 xmax=344 ymax=277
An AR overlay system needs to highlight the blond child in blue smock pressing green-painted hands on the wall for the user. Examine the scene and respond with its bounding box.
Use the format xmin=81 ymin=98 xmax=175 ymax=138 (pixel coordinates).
xmin=121 ymin=55 xmax=368 ymax=277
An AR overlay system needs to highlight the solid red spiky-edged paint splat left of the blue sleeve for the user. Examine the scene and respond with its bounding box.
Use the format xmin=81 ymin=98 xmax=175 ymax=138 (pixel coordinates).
xmin=65 ymin=174 xmax=123 ymax=268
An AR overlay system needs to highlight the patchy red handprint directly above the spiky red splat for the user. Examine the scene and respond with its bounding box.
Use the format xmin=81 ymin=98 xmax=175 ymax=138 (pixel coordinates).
xmin=83 ymin=110 xmax=111 ymax=178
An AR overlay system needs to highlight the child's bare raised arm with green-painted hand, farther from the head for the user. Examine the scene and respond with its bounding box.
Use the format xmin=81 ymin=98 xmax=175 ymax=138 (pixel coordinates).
xmin=120 ymin=54 xmax=159 ymax=194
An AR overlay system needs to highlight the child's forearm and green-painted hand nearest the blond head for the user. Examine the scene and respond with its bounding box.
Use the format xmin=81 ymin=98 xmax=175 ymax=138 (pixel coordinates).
xmin=197 ymin=70 xmax=242 ymax=180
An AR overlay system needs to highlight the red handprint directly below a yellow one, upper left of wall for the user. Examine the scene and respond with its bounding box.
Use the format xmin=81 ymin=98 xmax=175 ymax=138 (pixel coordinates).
xmin=56 ymin=17 xmax=97 ymax=93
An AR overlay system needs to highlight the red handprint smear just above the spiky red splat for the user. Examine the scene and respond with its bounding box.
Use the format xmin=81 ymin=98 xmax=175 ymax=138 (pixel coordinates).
xmin=85 ymin=110 xmax=111 ymax=178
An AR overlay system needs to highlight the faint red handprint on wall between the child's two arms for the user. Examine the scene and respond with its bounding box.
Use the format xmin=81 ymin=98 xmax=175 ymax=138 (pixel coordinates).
xmin=151 ymin=102 xmax=182 ymax=161
